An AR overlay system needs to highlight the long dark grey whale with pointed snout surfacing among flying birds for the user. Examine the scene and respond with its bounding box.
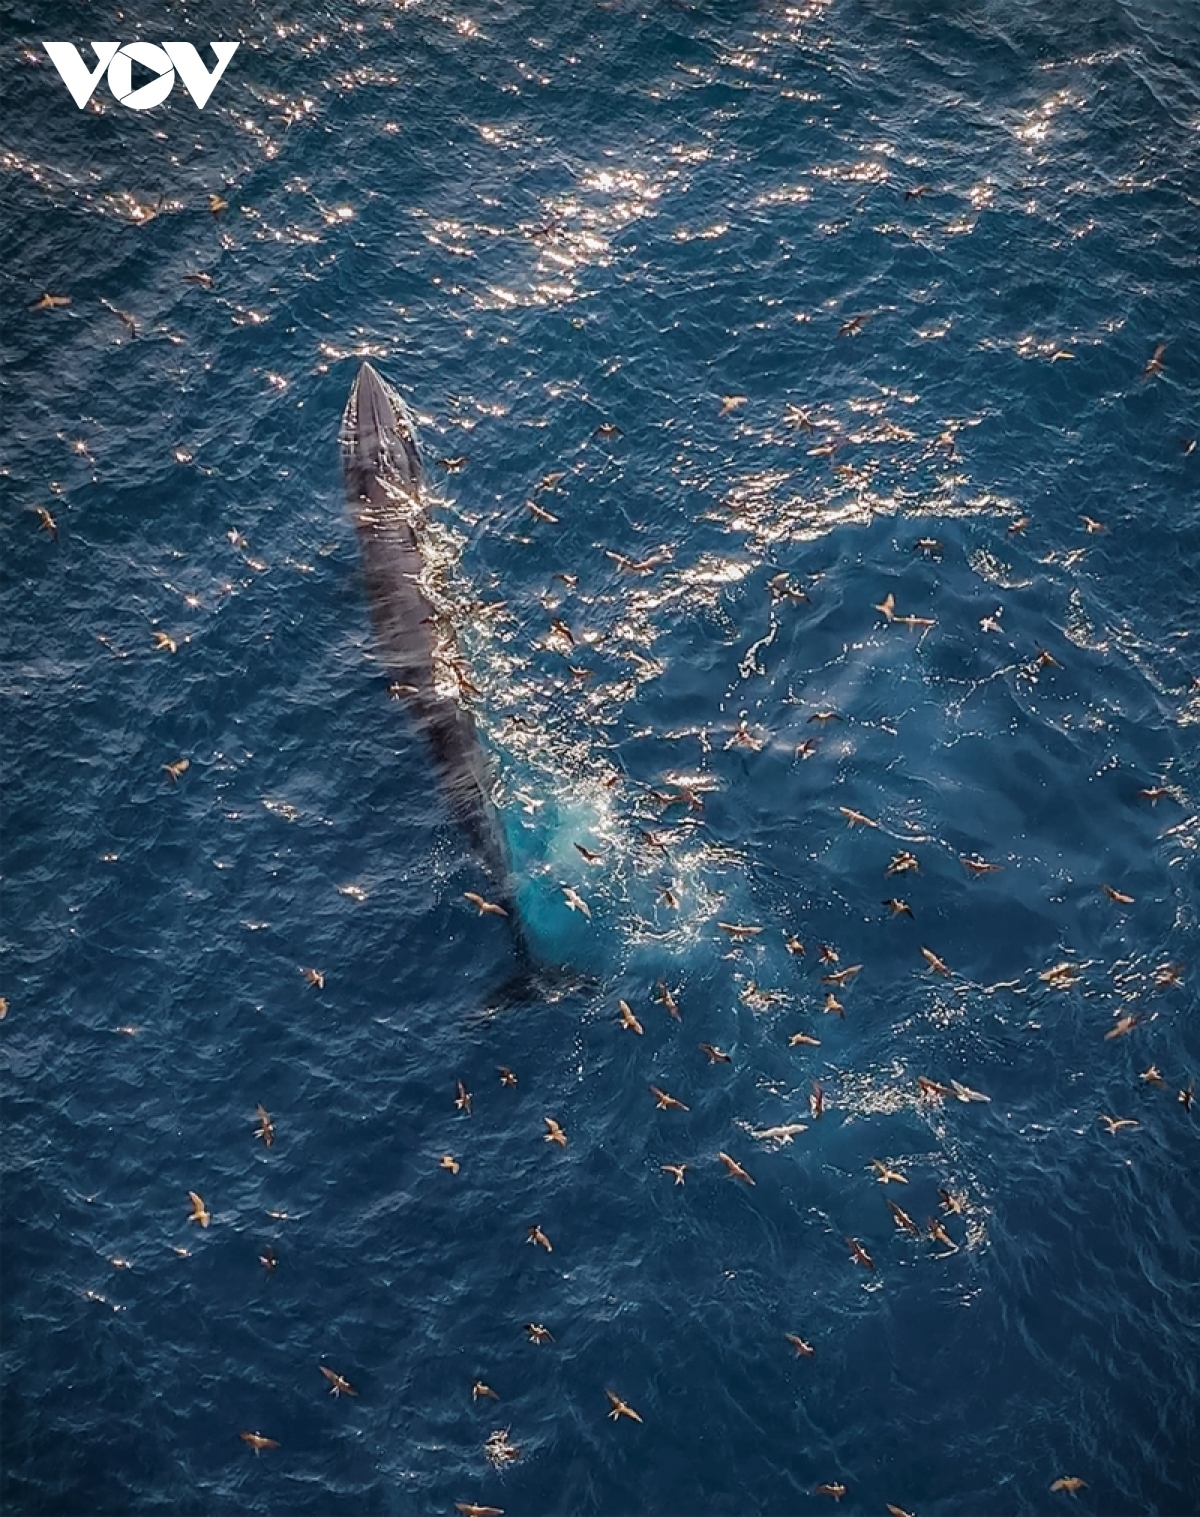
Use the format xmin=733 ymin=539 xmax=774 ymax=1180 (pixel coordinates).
xmin=341 ymin=363 xmax=523 ymax=922
